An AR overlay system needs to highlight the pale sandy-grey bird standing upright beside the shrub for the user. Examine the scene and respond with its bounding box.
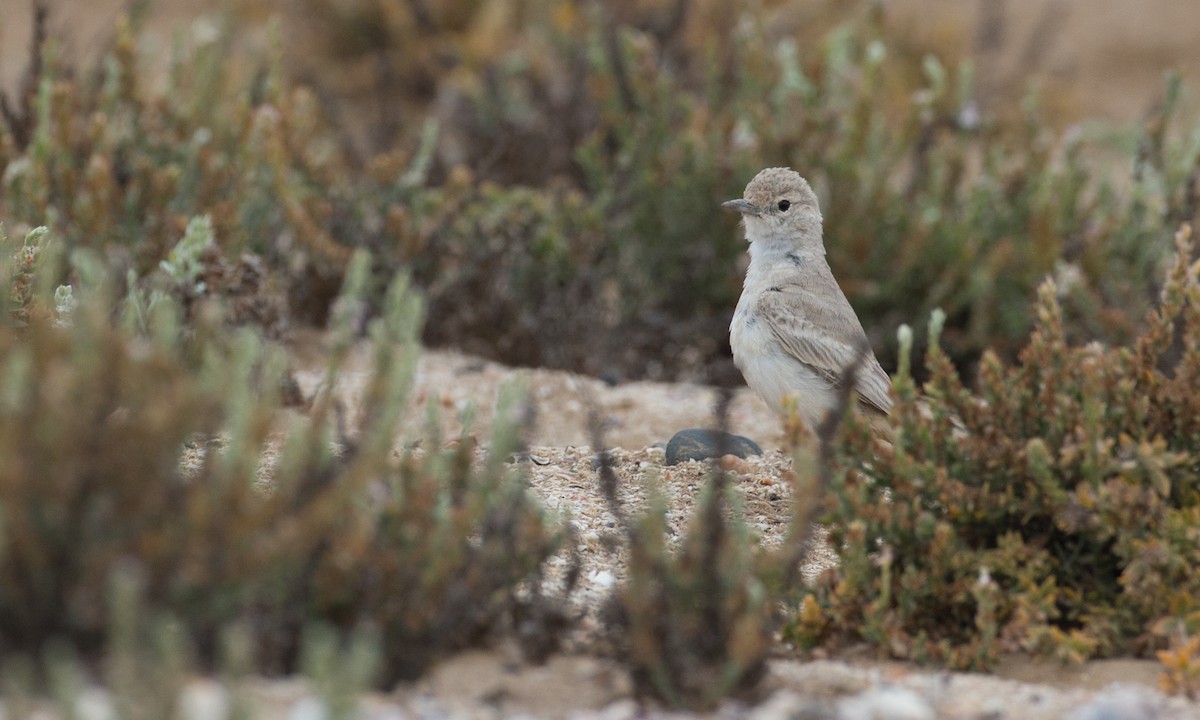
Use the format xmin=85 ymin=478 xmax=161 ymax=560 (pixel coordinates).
xmin=724 ymin=168 xmax=892 ymax=430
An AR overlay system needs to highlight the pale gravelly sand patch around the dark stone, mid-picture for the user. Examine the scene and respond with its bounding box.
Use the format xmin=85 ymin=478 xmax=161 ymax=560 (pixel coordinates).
xmin=295 ymin=342 xmax=816 ymax=646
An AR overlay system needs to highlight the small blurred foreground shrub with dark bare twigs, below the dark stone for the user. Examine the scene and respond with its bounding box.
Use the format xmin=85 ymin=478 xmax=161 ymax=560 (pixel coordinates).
xmin=593 ymin=388 xmax=857 ymax=709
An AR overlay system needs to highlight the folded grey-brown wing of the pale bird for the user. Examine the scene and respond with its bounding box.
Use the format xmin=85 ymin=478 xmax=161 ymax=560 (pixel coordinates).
xmin=756 ymin=283 xmax=892 ymax=414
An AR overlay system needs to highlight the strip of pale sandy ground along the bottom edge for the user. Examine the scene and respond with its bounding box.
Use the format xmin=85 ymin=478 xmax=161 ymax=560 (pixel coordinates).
xmin=204 ymin=652 xmax=1200 ymax=720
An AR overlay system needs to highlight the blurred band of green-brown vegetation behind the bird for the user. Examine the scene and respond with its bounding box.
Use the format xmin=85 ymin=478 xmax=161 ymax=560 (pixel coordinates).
xmin=0 ymin=0 xmax=1200 ymax=384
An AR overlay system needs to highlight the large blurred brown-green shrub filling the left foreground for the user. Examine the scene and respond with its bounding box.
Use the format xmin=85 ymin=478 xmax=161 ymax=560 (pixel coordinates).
xmin=0 ymin=238 xmax=558 ymax=683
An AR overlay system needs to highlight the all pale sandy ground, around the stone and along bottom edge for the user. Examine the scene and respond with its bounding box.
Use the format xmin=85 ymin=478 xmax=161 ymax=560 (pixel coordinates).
xmin=283 ymin=350 xmax=1200 ymax=720
